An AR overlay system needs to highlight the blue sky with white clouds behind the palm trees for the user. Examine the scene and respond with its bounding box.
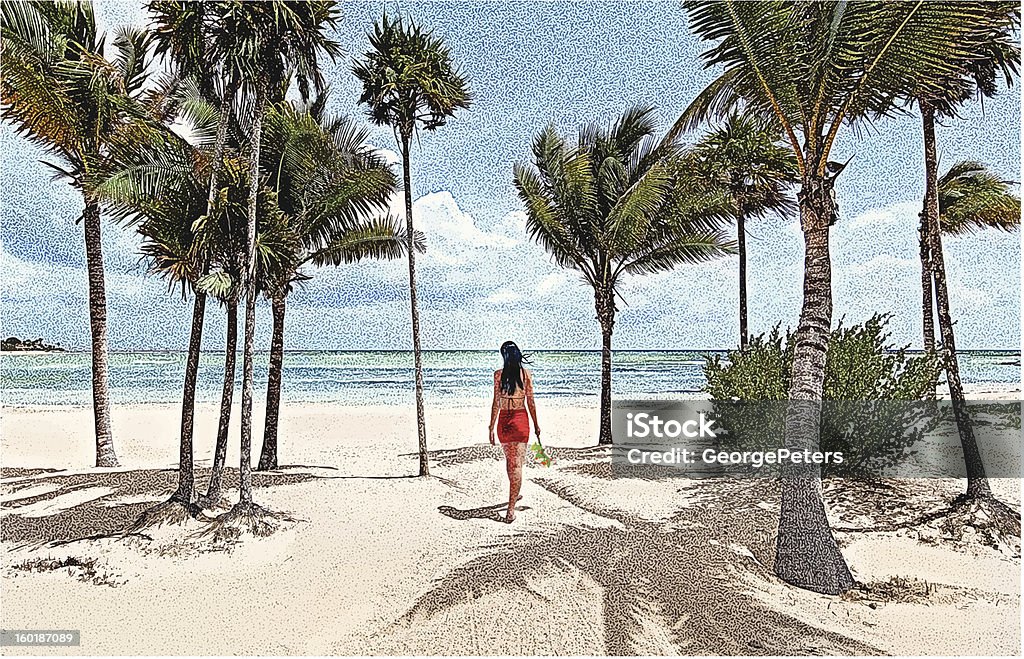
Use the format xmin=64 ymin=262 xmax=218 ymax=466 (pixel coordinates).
xmin=0 ymin=0 xmax=1021 ymax=349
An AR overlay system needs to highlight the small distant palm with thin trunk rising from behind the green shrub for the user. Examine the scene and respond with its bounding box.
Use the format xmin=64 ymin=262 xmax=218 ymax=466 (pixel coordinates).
xmin=691 ymin=112 xmax=798 ymax=350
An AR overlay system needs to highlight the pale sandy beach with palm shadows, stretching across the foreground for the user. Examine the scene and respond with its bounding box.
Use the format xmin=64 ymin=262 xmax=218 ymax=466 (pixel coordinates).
xmin=0 ymin=386 xmax=1020 ymax=655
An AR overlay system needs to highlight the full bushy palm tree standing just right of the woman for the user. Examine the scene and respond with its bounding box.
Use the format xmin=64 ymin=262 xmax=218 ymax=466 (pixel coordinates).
xmin=513 ymin=107 xmax=733 ymax=444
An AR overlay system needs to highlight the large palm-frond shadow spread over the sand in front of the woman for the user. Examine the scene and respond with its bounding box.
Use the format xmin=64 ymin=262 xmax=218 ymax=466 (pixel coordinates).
xmin=380 ymin=474 xmax=879 ymax=655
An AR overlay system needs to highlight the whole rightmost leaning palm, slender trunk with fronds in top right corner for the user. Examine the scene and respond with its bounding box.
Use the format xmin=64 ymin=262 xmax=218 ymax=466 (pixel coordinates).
xmin=912 ymin=2 xmax=1020 ymax=499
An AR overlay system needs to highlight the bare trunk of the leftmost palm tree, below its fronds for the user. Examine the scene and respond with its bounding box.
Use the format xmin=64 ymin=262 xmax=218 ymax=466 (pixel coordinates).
xmin=82 ymin=197 xmax=119 ymax=467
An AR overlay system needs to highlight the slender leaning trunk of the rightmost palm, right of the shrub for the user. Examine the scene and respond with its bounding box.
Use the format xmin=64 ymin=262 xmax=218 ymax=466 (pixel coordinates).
xmin=919 ymin=102 xmax=992 ymax=498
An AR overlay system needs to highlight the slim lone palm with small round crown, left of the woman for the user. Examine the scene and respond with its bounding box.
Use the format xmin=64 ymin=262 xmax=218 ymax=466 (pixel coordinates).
xmin=352 ymin=14 xmax=471 ymax=476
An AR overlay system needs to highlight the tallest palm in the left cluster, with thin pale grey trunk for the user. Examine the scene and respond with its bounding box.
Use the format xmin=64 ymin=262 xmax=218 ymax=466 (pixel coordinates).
xmin=217 ymin=0 xmax=341 ymax=511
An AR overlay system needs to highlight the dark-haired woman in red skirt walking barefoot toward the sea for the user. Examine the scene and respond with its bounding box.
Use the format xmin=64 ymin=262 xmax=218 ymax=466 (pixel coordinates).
xmin=487 ymin=341 xmax=541 ymax=524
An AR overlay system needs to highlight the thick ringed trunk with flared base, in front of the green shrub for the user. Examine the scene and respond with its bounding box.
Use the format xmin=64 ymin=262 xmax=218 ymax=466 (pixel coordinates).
xmin=775 ymin=172 xmax=853 ymax=595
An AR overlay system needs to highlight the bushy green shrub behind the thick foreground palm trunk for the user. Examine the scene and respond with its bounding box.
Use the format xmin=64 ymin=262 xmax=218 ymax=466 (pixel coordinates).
xmin=705 ymin=314 xmax=941 ymax=476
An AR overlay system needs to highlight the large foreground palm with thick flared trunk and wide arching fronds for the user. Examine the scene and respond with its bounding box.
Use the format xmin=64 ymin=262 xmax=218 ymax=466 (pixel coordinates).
xmin=676 ymin=0 xmax=1003 ymax=594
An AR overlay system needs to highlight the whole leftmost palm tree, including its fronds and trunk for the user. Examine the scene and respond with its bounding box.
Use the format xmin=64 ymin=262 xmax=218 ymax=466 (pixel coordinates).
xmin=0 ymin=0 xmax=148 ymax=467
